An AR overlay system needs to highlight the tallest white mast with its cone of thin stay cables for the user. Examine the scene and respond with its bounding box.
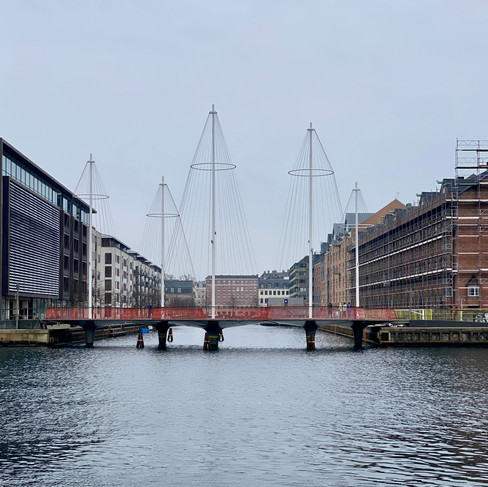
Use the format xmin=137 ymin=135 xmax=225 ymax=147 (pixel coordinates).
xmin=180 ymin=106 xmax=256 ymax=320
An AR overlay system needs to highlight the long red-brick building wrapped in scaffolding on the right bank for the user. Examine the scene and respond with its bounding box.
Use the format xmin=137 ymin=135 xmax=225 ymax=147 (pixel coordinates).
xmin=347 ymin=141 xmax=488 ymax=308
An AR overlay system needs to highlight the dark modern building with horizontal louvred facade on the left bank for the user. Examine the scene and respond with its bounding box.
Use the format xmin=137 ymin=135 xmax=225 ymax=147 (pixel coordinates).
xmin=0 ymin=138 xmax=89 ymax=319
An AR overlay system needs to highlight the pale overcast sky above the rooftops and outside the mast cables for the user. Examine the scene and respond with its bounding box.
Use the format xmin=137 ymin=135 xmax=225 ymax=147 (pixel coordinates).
xmin=0 ymin=0 xmax=488 ymax=273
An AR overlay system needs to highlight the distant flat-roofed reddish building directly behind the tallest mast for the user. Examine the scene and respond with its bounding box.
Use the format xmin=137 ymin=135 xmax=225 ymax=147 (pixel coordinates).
xmin=205 ymin=275 xmax=258 ymax=307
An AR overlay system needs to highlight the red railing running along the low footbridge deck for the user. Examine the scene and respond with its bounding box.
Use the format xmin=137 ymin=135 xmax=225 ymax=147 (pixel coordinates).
xmin=46 ymin=306 xmax=397 ymax=321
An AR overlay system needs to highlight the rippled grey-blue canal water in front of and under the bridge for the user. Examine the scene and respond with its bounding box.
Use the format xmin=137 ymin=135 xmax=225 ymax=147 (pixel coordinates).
xmin=0 ymin=326 xmax=488 ymax=487
